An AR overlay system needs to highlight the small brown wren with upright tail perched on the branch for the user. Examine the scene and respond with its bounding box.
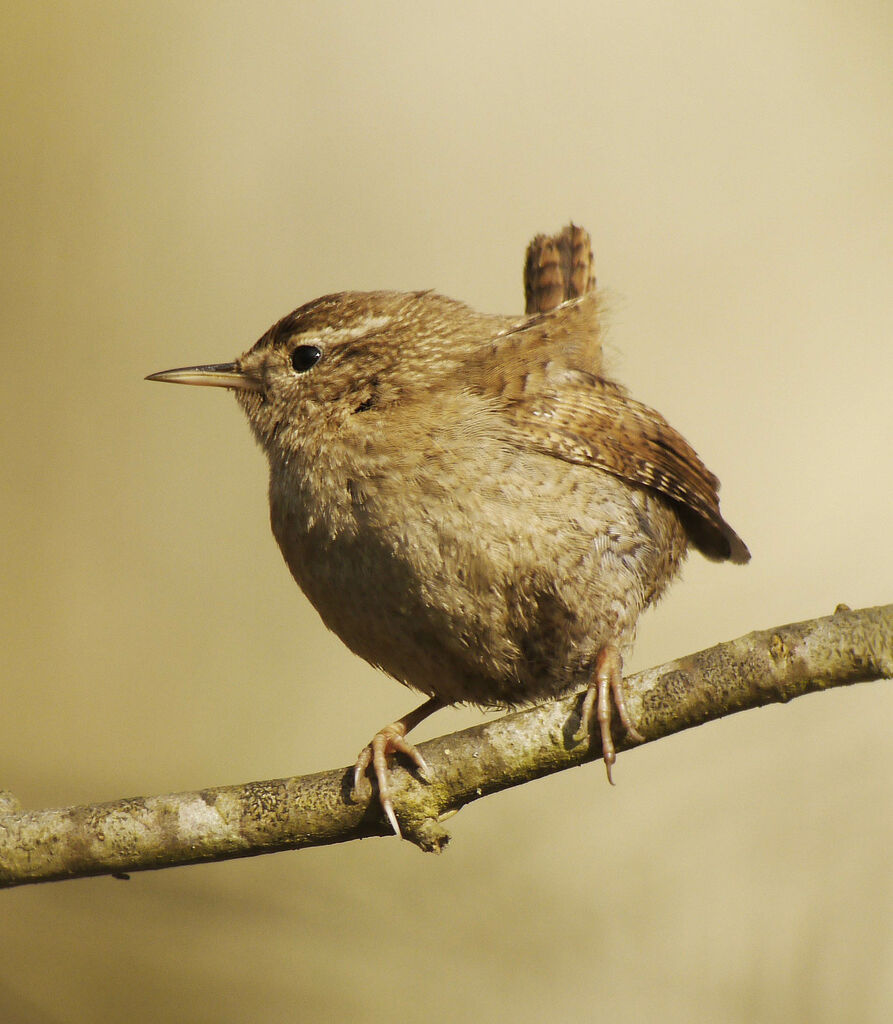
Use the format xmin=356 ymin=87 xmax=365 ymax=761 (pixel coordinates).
xmin=147 ymin=225 xmax=750 ymax=835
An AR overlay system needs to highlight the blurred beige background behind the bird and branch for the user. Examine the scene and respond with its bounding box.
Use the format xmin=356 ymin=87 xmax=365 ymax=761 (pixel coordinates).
xmin=0 ymin=0 xmax=893 ymax=1024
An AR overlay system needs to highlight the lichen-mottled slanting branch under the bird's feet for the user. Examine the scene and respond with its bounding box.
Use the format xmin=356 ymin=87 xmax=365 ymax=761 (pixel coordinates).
xmin=0 ymin=604 xmax=893 ymax=888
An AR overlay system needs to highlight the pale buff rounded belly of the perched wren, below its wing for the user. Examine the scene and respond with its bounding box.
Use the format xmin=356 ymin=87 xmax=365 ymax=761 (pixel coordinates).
xmin=271 ymin=450 xmax=685 ymax=707
